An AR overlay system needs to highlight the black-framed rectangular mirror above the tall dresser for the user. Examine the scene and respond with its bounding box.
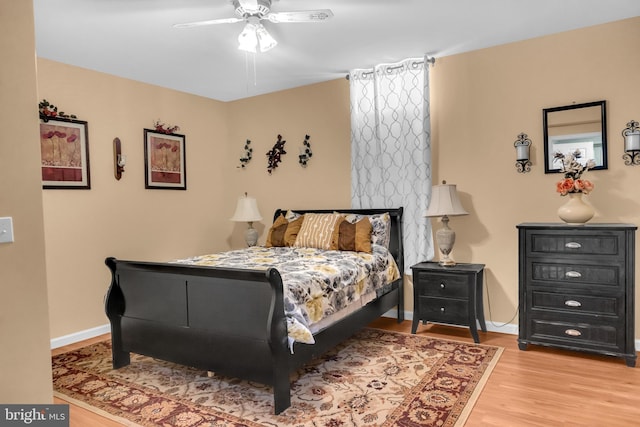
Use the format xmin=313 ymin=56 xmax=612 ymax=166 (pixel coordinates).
xmin=542 ymin=101 xmax=607 ymax=173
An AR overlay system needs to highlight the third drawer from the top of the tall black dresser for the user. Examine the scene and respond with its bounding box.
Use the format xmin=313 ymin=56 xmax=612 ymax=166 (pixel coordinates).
xmin=529 ymin=290 xmax=624 ymax=318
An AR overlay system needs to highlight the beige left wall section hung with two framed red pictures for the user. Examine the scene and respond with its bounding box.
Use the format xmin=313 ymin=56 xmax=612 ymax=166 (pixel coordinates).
xmin=38 ymin=59 xmax=230 ymax=338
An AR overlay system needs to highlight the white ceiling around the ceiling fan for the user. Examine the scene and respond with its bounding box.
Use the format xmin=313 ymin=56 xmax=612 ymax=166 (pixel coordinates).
xmin=33 ymin=0 xmax=640 ymax=101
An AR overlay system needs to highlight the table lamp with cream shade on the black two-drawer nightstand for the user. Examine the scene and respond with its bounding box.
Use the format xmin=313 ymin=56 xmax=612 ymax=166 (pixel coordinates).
xmin=426 ymin=181 xmax=469 ymax=267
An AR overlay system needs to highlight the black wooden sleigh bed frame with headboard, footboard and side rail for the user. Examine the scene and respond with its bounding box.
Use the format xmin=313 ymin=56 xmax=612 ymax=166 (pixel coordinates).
xmin=105 ymin=208 xmax=404 ymax=414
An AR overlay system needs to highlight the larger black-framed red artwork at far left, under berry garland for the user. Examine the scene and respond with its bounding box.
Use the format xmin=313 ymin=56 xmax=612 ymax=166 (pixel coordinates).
xmin=40 ymin=118 xmax=91 ymax=190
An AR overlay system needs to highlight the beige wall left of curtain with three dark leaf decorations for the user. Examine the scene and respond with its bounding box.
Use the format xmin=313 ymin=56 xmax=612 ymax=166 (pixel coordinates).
xmin=225 ymin=79 xmax=351 ymax=247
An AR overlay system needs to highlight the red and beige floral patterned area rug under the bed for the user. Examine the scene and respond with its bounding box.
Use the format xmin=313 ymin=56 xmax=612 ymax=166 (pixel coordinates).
xmin=52 ymin=329 xmax=502 ymax=427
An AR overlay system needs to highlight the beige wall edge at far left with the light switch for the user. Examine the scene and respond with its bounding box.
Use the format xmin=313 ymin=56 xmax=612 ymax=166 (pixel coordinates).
xmin=0 ymin=0 xmax=52 ymax=404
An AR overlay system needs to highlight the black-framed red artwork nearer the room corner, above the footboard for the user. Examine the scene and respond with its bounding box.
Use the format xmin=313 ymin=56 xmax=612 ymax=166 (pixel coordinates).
xmin=144 ymin=129 xmax=187 ymax=190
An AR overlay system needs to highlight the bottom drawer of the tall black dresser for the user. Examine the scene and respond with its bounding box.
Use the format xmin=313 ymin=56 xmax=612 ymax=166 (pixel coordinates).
xmin=527 ymin=318 xmax=624 ymax=352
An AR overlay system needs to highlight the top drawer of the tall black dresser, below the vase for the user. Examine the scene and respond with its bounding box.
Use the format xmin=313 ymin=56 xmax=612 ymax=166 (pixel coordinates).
xmin=527 ymin=230 xmax=624 ymax=258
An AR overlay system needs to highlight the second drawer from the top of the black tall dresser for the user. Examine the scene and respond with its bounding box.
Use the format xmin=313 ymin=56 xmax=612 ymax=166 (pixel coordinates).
xmin=528 ymin=260 xmax=623 ymax=287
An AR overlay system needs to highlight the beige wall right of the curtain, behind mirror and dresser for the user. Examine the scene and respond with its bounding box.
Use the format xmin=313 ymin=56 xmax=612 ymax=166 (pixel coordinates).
xmin=431 ymin=18 xmax=640 ymax=326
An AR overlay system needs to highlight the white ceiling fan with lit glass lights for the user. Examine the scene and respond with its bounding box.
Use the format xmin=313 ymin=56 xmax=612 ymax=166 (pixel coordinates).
xmin=174 ymin=0 xmax=333 ymax=53
